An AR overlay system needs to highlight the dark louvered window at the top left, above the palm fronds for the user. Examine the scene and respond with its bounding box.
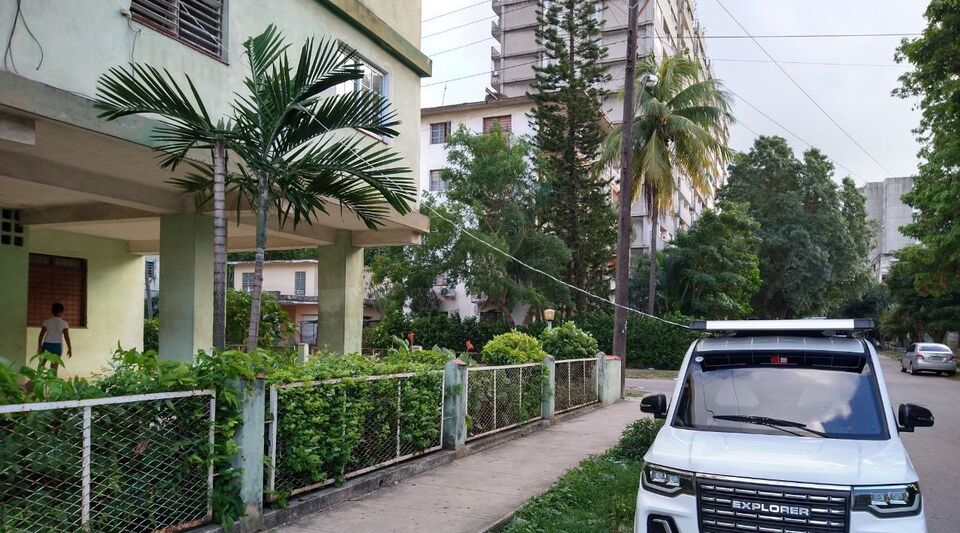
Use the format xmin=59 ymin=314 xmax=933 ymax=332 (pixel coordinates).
xmin=130 ymin=0 xmax=226 ymax=58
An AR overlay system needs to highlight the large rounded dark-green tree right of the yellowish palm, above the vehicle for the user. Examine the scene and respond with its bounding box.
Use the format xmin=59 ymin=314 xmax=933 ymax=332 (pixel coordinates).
xmin=720 ymin=136 xmax=870 ymax=318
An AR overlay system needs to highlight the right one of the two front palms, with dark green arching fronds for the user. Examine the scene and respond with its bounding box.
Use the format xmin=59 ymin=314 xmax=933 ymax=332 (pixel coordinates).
xmin=232 ymin=25 xmax=417 ymax=350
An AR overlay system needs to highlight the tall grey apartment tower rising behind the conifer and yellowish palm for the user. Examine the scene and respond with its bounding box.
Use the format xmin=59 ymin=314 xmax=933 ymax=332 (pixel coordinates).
xmin=490 ymin=0 xmax=727 ymax=252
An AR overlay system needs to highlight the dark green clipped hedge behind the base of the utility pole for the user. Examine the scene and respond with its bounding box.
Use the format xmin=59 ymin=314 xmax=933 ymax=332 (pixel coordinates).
xmin=577 ymin=312 xmax=699 ymax=370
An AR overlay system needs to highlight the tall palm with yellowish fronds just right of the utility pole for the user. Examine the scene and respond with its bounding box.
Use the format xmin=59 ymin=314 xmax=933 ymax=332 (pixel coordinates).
xmin=600 ymin=54 xmax=733 ymax=315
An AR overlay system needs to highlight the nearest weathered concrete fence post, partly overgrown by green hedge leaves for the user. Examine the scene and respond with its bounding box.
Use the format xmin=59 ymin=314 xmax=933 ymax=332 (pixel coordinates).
xmin=233 ymin=376 xmax=266 ymax=518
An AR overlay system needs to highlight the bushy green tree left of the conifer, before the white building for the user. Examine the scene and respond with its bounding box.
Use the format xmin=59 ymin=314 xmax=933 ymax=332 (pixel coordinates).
xmin=372 ymin=127 xmax=570 ymax=323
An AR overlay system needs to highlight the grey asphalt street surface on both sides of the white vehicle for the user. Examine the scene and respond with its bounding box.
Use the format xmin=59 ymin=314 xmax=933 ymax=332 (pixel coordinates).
xmin=627 ymin=355 xmax=960 ymax=533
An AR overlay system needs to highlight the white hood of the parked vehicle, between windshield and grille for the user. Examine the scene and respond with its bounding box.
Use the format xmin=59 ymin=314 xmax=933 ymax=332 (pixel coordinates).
xmin=644 ymin=425 xmax=917 ymax=485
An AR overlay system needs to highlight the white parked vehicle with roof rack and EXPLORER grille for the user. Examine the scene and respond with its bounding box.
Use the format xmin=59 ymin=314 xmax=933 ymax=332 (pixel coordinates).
xmin=634 ymin=319 xmax=933 ymax=533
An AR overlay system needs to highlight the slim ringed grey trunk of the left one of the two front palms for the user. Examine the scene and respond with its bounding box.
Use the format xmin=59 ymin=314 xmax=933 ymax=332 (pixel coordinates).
xmin=213 ymin=141 xmax=227 ymax=350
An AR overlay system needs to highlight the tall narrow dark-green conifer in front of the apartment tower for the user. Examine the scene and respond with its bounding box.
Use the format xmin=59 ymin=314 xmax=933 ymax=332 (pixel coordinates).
xmin=529 ymin=0 xmax=616 ymax=310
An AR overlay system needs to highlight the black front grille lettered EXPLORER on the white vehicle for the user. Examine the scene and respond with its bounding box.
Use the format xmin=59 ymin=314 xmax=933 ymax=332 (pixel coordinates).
xmin=697 ymin=478 xmax=850 ymax=533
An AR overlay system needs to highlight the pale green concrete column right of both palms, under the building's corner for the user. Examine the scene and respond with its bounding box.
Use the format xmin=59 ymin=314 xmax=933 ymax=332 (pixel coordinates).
xmin=316 ymin=230 xmax=363 ymax=353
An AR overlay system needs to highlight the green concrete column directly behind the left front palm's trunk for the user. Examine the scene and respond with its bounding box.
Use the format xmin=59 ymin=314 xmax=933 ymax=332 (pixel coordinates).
xmin=160 ymin=213 xmax=213 ymax=361
